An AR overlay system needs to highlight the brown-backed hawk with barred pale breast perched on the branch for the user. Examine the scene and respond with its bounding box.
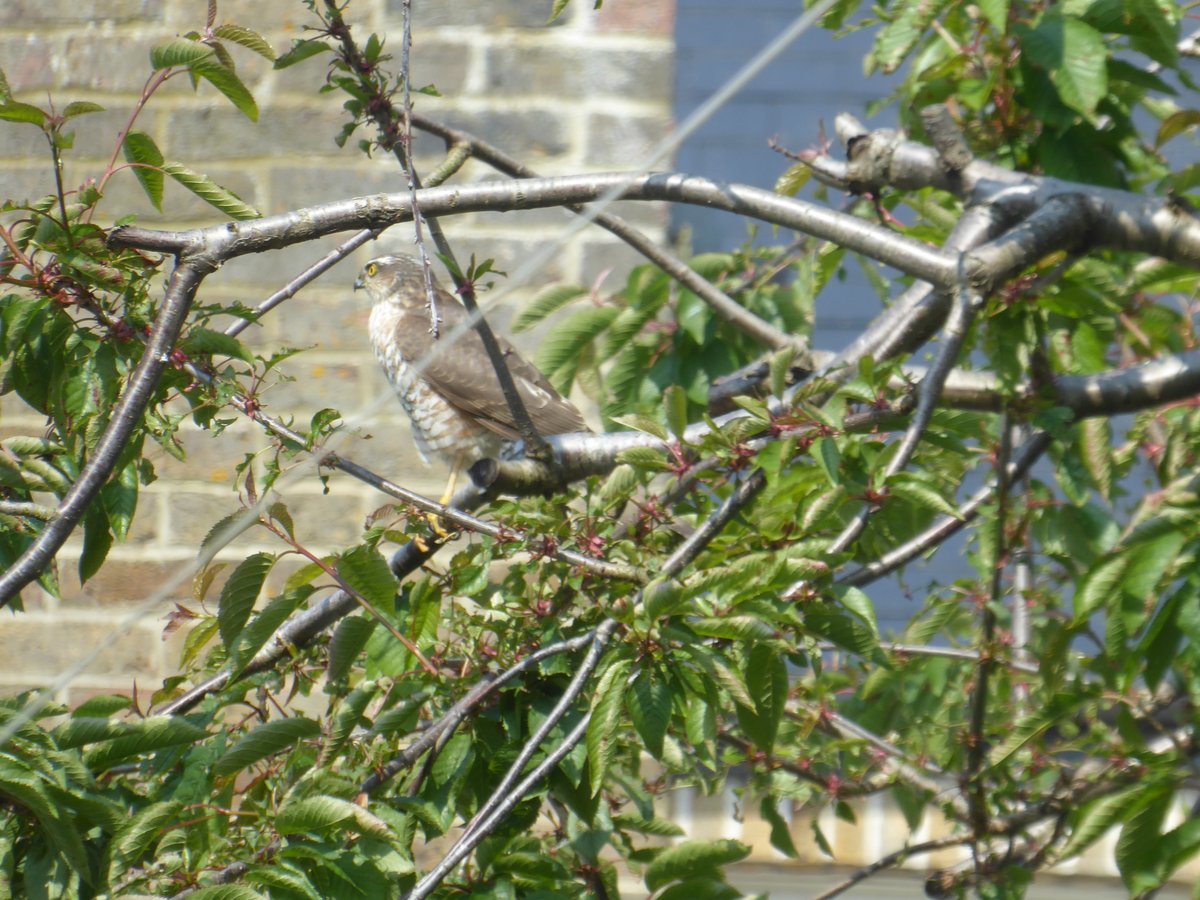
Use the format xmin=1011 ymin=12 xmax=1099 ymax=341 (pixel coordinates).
xmin=354 ymin=256 xmax=587 ymax=493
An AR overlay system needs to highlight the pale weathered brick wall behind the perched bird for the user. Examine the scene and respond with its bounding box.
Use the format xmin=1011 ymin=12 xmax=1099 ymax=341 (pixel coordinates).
xmin=0 ymin=0 xmax=673 ymax=702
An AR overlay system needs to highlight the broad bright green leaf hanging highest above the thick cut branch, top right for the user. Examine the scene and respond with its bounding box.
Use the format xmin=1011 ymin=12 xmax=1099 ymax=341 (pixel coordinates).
xmin=1016 ymin=10 xmax=1109 ymax=119
